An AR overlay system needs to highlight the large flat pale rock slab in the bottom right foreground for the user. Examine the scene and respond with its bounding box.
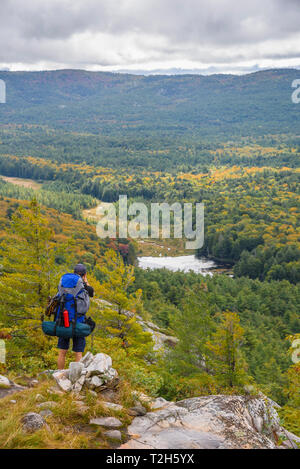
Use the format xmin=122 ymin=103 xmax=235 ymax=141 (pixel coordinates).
xmin=120 ymin=395 xmax=300 ymax=449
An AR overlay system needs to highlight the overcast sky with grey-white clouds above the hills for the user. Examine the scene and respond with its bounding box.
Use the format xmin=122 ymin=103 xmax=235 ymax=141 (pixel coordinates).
xmin=0 ymin=0 xmax=300 ymax=73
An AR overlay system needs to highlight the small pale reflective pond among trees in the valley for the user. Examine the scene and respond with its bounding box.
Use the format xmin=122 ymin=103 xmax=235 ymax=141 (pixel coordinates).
xmin=138 ymin=256 xmax=217 ymax=276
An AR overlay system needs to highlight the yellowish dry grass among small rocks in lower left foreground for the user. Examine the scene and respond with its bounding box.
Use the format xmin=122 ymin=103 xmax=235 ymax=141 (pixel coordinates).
xmin=0 ymin=377 xmax=132 ymax=449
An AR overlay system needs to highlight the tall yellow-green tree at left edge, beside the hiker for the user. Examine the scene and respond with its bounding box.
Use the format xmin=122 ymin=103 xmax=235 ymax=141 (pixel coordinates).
xmin=0 ymin=200 xmax=65 ymax=368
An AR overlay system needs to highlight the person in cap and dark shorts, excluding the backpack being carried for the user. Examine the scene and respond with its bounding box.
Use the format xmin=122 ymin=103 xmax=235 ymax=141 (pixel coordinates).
xmin=57 ymin=264 xmax=94 ymax=370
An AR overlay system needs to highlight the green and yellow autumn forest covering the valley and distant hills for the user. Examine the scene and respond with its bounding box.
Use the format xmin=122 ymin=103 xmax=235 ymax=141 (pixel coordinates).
xmin=0 ymin=70 xmax=300 ymax=442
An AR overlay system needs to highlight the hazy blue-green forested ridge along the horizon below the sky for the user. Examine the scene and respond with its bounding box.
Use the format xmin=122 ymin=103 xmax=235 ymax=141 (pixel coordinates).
xmin=0 ymin=69 xmax=300 ymax=137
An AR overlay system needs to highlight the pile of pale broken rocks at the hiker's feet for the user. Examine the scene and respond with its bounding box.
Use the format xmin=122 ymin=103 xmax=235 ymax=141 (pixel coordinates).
xmin=52 ymin=352 xmax=118 ymax=393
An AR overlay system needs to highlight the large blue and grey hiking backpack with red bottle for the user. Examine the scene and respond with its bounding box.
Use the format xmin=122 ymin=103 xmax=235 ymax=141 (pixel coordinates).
xmin=42 ymin=274 xmax=92 ymax=338
